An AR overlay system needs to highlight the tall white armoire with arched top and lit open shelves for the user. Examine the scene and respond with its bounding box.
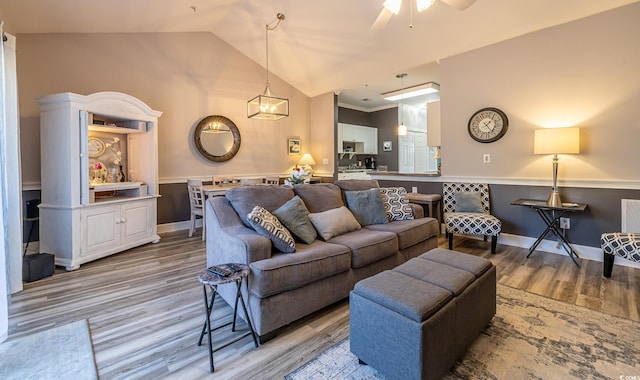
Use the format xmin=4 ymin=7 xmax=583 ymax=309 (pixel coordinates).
xmin=38 ymin=92 xmax=162 ymax=270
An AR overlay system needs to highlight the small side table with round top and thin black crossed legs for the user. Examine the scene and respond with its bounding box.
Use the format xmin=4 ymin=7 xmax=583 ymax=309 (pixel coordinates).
xmin=198 ymin=264 xmax=258 ymax=372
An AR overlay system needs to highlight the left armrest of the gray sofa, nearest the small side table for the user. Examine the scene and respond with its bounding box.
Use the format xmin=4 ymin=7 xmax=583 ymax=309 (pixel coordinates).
xmin=205 ymin=197 xmax=272 ymax=267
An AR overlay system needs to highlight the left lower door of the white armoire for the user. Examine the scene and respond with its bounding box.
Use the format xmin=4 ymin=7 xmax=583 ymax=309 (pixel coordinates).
xmin=80 ymin=205 xmax=120 ymax=256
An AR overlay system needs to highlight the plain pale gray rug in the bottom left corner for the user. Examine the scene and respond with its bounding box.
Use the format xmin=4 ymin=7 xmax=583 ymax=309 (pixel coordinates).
xmin=0 ymin=320 xmax=98 ymax=380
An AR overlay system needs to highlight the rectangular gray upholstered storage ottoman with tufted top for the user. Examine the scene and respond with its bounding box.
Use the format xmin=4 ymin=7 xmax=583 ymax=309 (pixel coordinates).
xmin=350 ymin=248 xmax=496 ymax=380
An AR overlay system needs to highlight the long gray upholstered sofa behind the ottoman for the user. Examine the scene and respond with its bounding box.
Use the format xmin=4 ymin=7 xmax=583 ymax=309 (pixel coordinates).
xmin=206 ymin=180 xmax=440 ymax=342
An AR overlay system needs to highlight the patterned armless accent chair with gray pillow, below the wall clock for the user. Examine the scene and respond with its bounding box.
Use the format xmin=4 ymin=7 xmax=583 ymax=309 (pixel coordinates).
xmin=442 ymin=183 xmax=502 ymax=254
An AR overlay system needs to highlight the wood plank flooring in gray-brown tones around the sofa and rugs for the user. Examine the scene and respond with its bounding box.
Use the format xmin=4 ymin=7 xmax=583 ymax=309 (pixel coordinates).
xmin=9 ymin=231 xmax=640 ymax=379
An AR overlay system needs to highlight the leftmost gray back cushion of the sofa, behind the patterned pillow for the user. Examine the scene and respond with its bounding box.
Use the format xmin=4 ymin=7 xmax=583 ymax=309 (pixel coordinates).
xmin=225 ymin=186 xmax=295 ymax=227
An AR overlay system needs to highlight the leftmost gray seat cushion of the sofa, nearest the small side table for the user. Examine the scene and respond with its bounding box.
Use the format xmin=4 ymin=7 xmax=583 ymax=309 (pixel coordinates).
xmin=249 ymin=240 xmax=351 ymax=298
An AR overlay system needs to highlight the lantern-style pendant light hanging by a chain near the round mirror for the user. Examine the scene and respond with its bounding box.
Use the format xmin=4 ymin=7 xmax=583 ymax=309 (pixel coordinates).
xmin=247 ymin=13 xmax=289 ymax=120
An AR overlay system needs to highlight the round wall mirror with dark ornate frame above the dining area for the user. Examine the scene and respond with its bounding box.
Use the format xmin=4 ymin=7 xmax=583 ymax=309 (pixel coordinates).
xmin=193 ymin=115 xmax=240 ymax=162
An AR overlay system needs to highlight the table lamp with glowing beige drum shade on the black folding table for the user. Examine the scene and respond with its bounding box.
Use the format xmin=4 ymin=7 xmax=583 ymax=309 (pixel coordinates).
xmin=533 ymin=127 xmax=580 ymax=207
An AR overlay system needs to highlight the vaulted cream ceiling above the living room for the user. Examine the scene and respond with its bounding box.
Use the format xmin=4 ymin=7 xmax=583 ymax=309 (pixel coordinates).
xmin=0 ymin=0 xmax=639 ymax=108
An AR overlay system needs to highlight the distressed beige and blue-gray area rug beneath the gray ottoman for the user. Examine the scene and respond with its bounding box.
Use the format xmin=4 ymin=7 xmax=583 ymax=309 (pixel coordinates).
xmin=285 ymin=285 xmax=640 ymax=380
